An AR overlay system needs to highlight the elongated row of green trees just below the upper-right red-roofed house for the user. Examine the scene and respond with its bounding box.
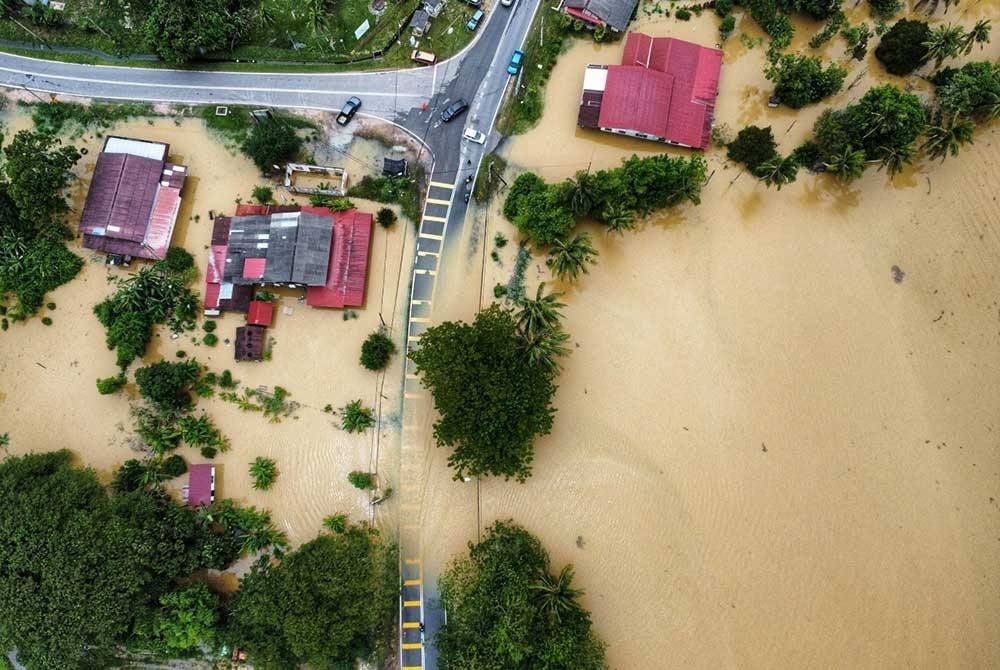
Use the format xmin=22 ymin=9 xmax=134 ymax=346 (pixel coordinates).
xmin=503 ymin=155 xmax=707 ymax=258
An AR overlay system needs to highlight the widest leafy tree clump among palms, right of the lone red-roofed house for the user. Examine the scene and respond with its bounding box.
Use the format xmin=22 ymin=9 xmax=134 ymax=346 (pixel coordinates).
xmin=813 ymin=85 xmax=927 ymax=181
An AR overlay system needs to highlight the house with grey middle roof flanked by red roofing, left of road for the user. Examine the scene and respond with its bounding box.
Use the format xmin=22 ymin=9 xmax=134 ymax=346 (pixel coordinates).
xmin=205 ymin=204 xmax=372 ymax=315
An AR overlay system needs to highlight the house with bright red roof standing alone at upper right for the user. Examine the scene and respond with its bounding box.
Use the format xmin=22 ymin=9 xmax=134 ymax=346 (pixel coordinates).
xmin=577 ymin=33 xmax=722 ymax=149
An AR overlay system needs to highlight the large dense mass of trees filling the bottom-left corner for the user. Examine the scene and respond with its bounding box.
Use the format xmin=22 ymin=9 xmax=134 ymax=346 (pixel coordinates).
xmin=0 ymin=450 xmax=284 ymax=668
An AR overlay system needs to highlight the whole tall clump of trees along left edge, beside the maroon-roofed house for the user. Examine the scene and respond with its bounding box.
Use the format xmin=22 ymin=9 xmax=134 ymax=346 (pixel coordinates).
xmin=0 ymin=130 xmax=83 ymax=322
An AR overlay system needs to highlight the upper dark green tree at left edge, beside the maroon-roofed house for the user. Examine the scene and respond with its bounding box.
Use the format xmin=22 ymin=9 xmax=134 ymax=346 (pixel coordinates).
xmin=3 ymin=130 xmax=80 ymax=236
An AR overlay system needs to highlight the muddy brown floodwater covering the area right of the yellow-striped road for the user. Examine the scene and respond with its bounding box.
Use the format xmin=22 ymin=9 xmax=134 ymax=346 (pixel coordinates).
xmin=414 ymin=2 xmax=1000 ymax=670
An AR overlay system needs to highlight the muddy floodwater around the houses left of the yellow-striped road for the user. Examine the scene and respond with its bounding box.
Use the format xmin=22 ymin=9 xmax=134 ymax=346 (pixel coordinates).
xmin=0 ymin=105 xmax=413 ymax=556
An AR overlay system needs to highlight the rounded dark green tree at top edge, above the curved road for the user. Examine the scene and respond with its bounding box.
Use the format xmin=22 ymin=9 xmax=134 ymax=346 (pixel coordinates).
xmin=142 ymin=0 xmax=253 ymax=64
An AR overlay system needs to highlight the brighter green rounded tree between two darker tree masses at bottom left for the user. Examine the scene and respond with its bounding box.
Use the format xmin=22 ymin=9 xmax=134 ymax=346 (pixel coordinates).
xmin=138 ymin=582 xmax=219 ymax=654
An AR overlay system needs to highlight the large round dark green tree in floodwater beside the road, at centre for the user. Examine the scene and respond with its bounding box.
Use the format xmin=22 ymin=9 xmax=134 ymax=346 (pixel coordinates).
xmin=409 ymin=304 xmax=555 ymax=481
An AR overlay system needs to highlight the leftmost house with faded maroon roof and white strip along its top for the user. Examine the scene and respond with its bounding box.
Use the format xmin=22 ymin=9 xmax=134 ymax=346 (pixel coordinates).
xmin=80 ymin=136 xmax=187 ymax=262
